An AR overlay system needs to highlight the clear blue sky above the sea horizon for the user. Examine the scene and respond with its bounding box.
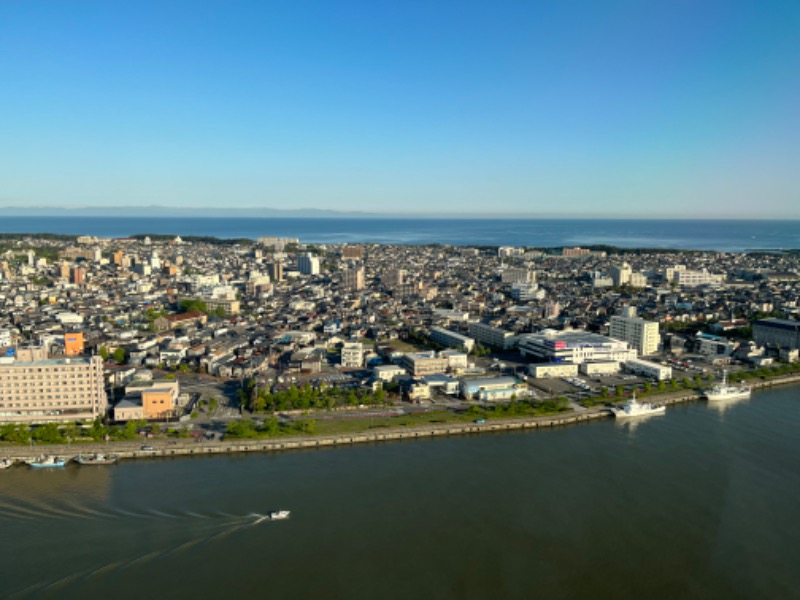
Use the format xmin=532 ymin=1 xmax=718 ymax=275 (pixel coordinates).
xmin=0 ymin=0 xmax=800 ymax=218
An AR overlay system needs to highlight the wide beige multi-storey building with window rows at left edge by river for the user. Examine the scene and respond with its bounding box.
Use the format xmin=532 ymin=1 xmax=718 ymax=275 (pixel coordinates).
xmin=0 ymin=347 xmax=108 ymax=424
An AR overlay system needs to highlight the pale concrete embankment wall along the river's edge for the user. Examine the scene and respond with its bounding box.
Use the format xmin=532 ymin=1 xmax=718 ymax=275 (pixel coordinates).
xmin=0 ymin=375 xmax=800 ymax=461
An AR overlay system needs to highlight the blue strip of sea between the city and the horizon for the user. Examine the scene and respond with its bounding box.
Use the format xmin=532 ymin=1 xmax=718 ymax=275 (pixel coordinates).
xmin=0 ymin=216 xmax=800 ymax=252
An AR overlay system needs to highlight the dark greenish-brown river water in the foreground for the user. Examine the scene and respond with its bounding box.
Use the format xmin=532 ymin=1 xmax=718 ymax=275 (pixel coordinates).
xmin=0 ymin=386 xmax=800 ymax=599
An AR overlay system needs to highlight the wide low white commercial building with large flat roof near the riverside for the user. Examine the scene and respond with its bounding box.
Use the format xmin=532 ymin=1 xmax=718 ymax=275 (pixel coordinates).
xmin=519 ymin=329 xmax=636 ymax=364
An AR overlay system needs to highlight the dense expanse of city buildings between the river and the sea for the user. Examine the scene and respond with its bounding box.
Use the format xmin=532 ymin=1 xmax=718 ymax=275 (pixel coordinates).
xmin=0 ymin=236 xmax=800 ymax=423
